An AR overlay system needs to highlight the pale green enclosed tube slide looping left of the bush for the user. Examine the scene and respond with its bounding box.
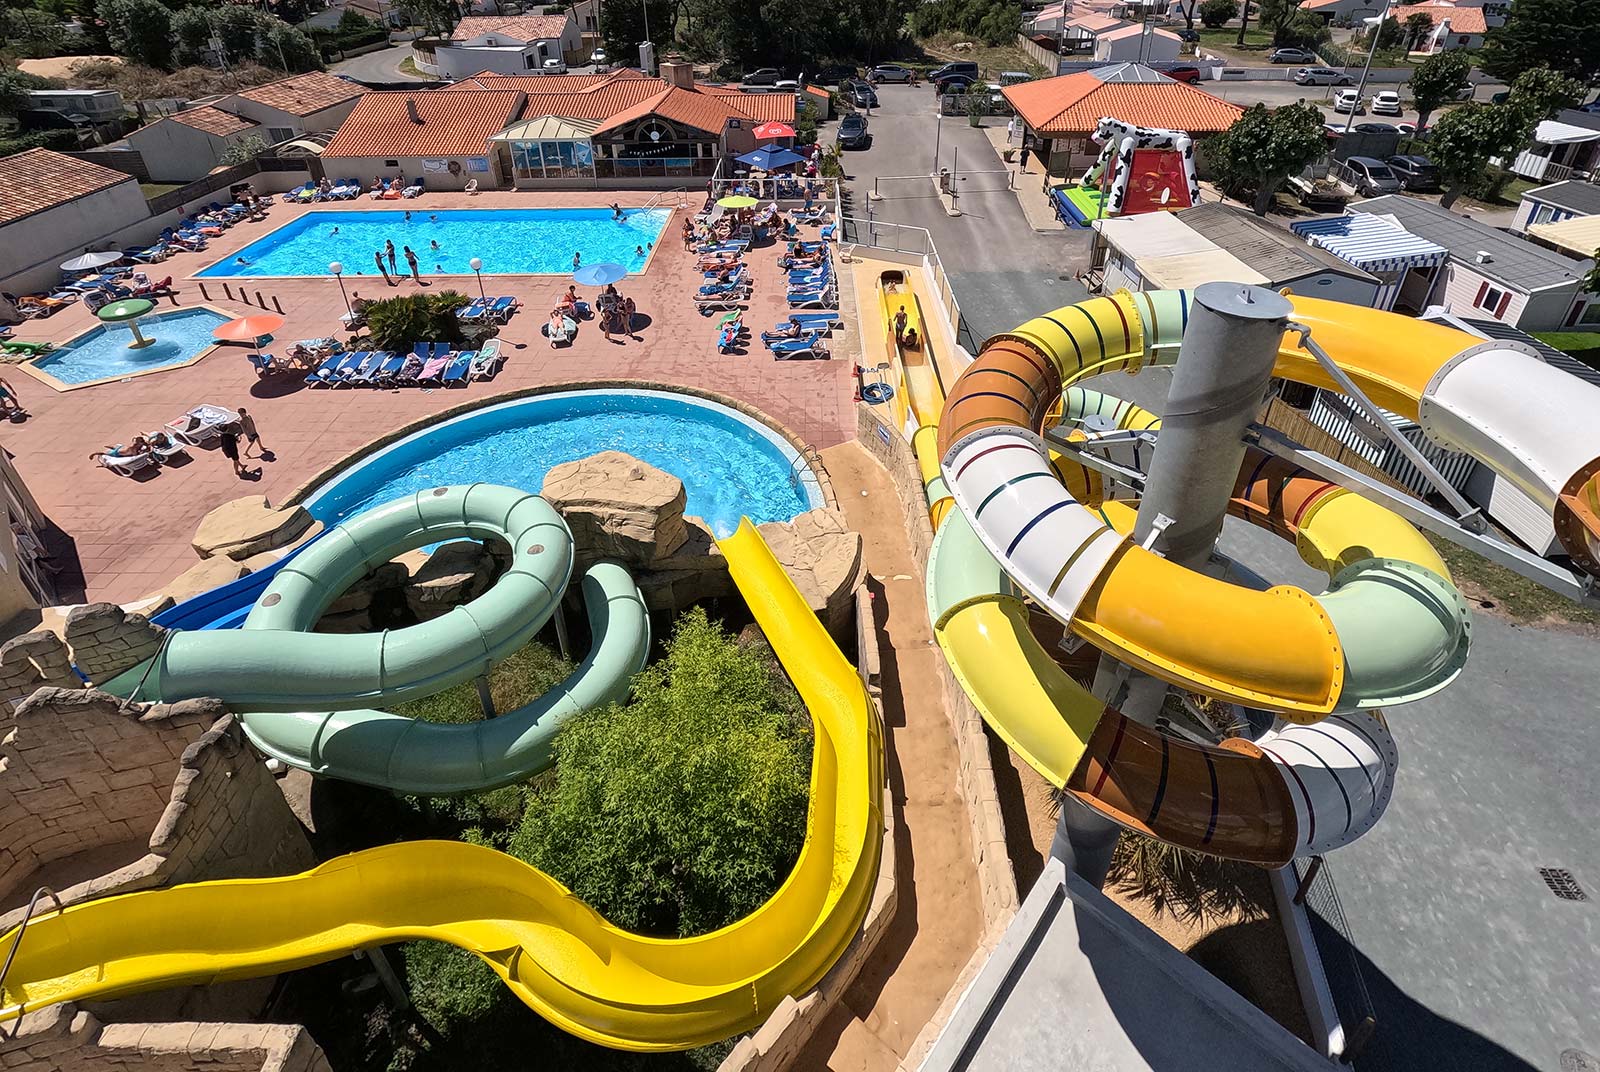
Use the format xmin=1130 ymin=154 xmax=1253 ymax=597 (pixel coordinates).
xmin=102 ymin=483 xmax=650 ymax=795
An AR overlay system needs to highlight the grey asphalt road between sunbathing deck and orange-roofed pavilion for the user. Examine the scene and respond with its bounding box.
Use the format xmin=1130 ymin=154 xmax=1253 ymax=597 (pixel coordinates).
xmin=822 ymin=85 xmax=1090 ymax=349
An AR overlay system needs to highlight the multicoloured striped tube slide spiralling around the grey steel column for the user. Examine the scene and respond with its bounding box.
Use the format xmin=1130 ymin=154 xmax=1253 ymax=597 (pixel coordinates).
xmin=928 ymin=291 xmax=1600 ymax=864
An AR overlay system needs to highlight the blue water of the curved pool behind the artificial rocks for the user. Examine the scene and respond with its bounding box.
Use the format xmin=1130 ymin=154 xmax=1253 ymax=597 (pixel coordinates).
xmin=306 ymin=390 xmax=824 ymax=536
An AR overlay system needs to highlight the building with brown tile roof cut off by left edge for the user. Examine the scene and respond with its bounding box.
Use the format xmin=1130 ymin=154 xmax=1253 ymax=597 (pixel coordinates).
xmin=0 ymin=149 xmax=150 ymax=294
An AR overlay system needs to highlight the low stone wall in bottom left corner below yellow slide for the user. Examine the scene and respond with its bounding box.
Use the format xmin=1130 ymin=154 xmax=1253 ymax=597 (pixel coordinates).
xmin=0 ymin=1005 xmax=333 ymax=1072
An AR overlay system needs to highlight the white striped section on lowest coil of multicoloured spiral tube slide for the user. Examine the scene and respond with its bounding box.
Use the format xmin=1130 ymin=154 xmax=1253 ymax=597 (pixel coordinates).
xmin=1256 ymin=710 xmax=1400 ymax=856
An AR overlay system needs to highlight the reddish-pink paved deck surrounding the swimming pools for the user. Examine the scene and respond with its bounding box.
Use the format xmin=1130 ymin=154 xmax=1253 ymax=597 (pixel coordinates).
xmin=3 ymin=190 xmax=854 ymax=602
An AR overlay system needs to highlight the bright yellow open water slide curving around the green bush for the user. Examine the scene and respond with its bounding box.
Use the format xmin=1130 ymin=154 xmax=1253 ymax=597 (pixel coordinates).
xmin=0 ymin=520 xmax=883 ymax=1051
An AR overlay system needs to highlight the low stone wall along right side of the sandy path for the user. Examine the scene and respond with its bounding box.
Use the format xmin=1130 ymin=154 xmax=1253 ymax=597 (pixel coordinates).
xmin=856 ymin=405 xmax=1019 ymax=930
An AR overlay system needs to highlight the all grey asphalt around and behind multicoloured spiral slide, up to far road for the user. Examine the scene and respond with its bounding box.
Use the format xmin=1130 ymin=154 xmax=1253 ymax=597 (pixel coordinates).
xmin=824 ymin=83 xmax=1600 ymax=1072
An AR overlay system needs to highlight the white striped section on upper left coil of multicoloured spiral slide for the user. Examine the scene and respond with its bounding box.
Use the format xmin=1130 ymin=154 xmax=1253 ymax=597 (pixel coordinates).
xmin=944 ymin=427 xmax=1123 ymax=622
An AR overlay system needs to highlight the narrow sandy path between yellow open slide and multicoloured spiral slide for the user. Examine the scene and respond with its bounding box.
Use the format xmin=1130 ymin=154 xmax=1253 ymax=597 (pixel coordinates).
xmin=794 ymin=442 xmax=982 ymax=1072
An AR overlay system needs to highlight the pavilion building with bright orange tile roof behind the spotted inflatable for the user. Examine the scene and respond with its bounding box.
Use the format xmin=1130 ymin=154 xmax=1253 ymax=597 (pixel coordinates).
xmin=1002 ymin=64 xmax=1243 ymax=179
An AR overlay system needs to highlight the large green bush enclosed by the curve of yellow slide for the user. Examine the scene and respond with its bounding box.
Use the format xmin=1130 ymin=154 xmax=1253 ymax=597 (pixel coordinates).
xmin=510 ymin=608 xmax=810 ymax=936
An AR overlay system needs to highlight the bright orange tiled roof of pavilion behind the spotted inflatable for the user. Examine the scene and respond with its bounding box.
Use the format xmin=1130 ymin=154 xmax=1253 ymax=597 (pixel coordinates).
xmin=1002 ymin=72 xmax=1243 ymax=136
